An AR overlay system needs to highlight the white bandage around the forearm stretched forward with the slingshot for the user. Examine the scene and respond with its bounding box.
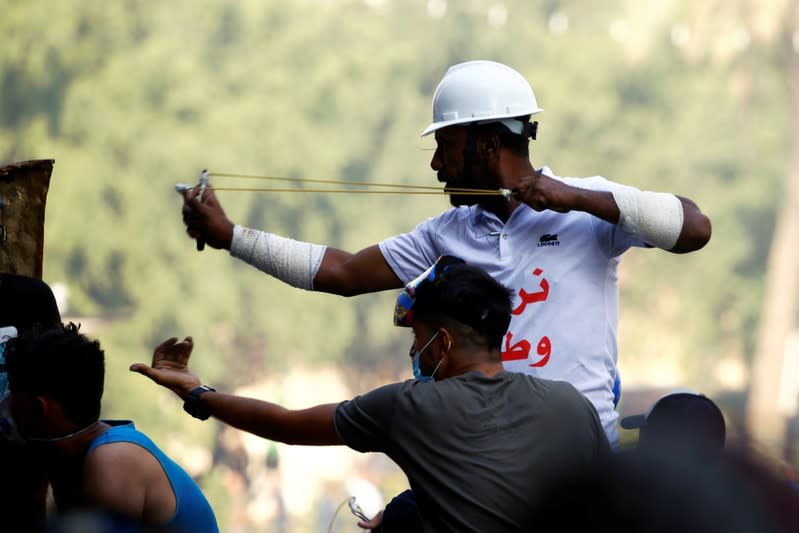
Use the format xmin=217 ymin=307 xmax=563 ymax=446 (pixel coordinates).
xmin=230 ymin=225 xmax=327 ymax=291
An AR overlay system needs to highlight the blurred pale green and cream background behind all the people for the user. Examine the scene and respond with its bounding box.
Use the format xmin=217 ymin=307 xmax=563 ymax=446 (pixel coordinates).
xmin=0 ymin=0 xmax=799 ymax=532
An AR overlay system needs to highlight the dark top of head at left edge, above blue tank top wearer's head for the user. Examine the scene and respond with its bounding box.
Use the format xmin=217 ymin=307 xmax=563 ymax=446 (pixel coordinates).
xmin=0 ymin=272 xmax=61 ymax=332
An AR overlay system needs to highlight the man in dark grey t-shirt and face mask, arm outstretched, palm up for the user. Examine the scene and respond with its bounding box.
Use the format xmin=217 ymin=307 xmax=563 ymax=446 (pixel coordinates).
xmin=131 ymin=256 xmax=609 ymax=531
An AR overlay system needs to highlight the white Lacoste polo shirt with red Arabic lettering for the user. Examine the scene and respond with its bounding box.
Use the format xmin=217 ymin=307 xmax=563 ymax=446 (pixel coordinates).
xmin=379 ymin=168 xmax=646 ymax=448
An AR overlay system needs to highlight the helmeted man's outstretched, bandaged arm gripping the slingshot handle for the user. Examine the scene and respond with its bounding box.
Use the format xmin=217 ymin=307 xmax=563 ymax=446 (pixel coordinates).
xmin=182 ymin=187 xmax=402 ymax=296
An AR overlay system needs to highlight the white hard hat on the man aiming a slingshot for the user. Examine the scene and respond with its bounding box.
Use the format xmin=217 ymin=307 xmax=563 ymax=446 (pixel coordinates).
xmin=422 ymin=61 xmax=543 ymax=137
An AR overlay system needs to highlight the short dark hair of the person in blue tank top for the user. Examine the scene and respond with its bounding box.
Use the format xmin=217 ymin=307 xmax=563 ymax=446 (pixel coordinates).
xmin=4 ymin=322 xmax=105 ymax=426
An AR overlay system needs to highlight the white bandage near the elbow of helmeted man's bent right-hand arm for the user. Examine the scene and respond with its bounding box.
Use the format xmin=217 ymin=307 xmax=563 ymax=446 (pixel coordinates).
xmin=613 ymin=187 xmax=684 ymax=250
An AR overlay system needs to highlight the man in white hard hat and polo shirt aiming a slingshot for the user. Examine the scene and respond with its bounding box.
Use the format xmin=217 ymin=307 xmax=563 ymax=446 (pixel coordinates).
xmin=183 ymin=61 xmax=711 ymax=445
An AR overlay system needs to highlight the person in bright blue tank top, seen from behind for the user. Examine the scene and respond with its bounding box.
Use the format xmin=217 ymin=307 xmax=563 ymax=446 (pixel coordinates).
xmin=4 ymin=323 xmax=219 ymax=533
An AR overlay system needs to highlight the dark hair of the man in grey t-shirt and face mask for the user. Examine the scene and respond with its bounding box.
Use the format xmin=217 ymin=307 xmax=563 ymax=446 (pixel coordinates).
xmin=414 ymin=264 xmax=512 ymax=348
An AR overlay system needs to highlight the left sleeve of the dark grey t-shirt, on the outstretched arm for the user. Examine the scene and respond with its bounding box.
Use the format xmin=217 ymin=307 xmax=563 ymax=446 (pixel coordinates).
xmin=333 ymin=383 xmax=402 ymax=452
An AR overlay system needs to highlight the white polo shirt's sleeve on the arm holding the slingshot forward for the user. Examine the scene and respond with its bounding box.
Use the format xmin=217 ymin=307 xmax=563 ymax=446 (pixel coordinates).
xmin=378 ymin=217 xmax=440 ymax=284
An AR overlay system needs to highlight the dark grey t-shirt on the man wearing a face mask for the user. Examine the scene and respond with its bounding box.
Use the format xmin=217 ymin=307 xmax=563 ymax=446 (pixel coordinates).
xmin=334 ymin=371 xmax=609 ymax=532
